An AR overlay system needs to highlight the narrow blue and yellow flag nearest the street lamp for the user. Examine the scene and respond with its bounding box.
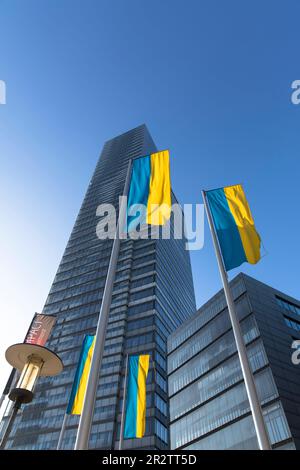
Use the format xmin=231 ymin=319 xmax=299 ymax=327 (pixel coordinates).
xmin=66 ymin=335 xmax=95 ymax=415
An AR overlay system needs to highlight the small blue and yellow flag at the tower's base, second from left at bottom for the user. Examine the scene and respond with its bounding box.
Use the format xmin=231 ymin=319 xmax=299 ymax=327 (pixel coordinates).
xmin=124 ymin=354 xmax=150 ymax=439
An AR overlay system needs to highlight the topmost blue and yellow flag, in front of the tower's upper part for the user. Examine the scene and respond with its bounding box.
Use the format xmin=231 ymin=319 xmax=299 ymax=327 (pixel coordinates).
xmin=127 ymin=150 xmax=172 ymax=232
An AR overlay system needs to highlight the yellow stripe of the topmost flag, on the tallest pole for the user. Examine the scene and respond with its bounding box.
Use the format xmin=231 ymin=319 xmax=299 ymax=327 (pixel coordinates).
xmin=147 ymin=150 xmax=172 ymax=225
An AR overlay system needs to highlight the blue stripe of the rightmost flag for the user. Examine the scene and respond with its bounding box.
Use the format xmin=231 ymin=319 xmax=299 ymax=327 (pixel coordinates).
xmin=206 ymin=188 xmax=247 ymax=271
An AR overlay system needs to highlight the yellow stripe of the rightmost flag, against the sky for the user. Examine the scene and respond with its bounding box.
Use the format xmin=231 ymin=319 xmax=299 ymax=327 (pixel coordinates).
xmin=224 ymin=184 xmax=260 ymax=264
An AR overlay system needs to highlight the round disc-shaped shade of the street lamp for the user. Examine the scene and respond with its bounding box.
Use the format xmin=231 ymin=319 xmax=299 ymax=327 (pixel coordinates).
xmin=5 ymin=343 xmax=63 ymax=377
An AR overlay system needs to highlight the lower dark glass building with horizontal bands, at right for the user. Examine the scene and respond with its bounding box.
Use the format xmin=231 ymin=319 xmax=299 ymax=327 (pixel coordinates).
xmin=168 ymin=274 xmax=300 ymax=450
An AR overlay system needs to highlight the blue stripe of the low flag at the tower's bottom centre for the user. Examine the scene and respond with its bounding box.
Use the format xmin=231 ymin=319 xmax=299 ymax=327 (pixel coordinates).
xmin=124 ymin=356 xmax=139 ymax=439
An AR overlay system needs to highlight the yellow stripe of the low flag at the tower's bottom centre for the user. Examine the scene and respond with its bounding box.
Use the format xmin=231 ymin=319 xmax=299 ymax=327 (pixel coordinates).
xmin=136 ymin=354 xmax=149 ymax=437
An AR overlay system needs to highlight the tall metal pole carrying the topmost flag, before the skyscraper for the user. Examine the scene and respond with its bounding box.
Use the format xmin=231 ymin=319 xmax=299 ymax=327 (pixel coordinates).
xmin=74 ymin=160 xmax=132 ymax=450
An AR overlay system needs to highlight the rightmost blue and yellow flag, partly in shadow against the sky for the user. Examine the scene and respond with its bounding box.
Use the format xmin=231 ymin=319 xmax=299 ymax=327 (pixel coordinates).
xmin=206 ymin=184 xmax=261 ymax=271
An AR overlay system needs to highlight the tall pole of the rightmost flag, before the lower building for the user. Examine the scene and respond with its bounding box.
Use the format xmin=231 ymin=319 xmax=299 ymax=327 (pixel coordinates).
xmin=202 ymin=191 xmax=272 ymax=450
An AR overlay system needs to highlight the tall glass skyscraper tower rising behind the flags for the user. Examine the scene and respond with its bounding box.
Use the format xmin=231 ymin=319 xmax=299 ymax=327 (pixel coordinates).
xmin=2 ymin=125 xmax=195 ymax=449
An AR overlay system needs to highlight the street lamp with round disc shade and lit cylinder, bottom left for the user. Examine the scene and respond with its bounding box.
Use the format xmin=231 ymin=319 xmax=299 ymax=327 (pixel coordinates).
xmin=0 ymin=343 xmax=63 ymax=449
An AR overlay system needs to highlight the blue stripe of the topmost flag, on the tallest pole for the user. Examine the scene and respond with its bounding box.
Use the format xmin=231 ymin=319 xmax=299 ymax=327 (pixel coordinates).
xmin=127 ymin=155 xmax=151 ymax=232
